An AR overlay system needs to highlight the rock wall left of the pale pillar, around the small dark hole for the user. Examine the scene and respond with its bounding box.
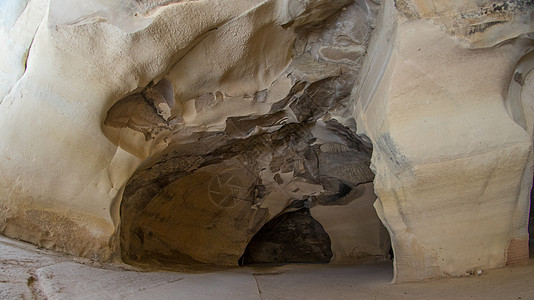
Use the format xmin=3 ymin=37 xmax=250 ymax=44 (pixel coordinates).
xmin=0 ymin=0 xmax=389 ymax=265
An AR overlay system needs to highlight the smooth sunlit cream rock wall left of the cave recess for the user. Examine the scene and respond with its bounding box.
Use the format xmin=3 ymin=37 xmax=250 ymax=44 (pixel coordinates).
xmin=0 ymin=1 xmax=322 ymax=260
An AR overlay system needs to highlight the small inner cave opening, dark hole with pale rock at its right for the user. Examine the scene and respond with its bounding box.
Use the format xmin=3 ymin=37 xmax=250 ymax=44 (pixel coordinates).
xmin=239 ymin=182 xmax=393 ymax=266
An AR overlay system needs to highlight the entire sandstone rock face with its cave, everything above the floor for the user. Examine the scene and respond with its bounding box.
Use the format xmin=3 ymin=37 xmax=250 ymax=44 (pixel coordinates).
xmin=0 ymin=0 xmax=534 ymax=284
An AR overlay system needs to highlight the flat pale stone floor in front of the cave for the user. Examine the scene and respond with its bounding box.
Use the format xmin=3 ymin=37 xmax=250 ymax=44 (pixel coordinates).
xmin=0 ymin=236 xmax=534 ymax=300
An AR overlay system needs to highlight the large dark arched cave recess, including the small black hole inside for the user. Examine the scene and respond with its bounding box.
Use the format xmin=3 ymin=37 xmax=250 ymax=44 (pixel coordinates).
xmin=120 ymin=122 xmax=391 ymax=269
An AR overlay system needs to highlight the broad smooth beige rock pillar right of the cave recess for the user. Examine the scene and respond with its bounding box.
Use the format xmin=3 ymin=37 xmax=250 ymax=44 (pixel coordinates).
xmin=353 ymin=1 xmax=532 ymax=281
